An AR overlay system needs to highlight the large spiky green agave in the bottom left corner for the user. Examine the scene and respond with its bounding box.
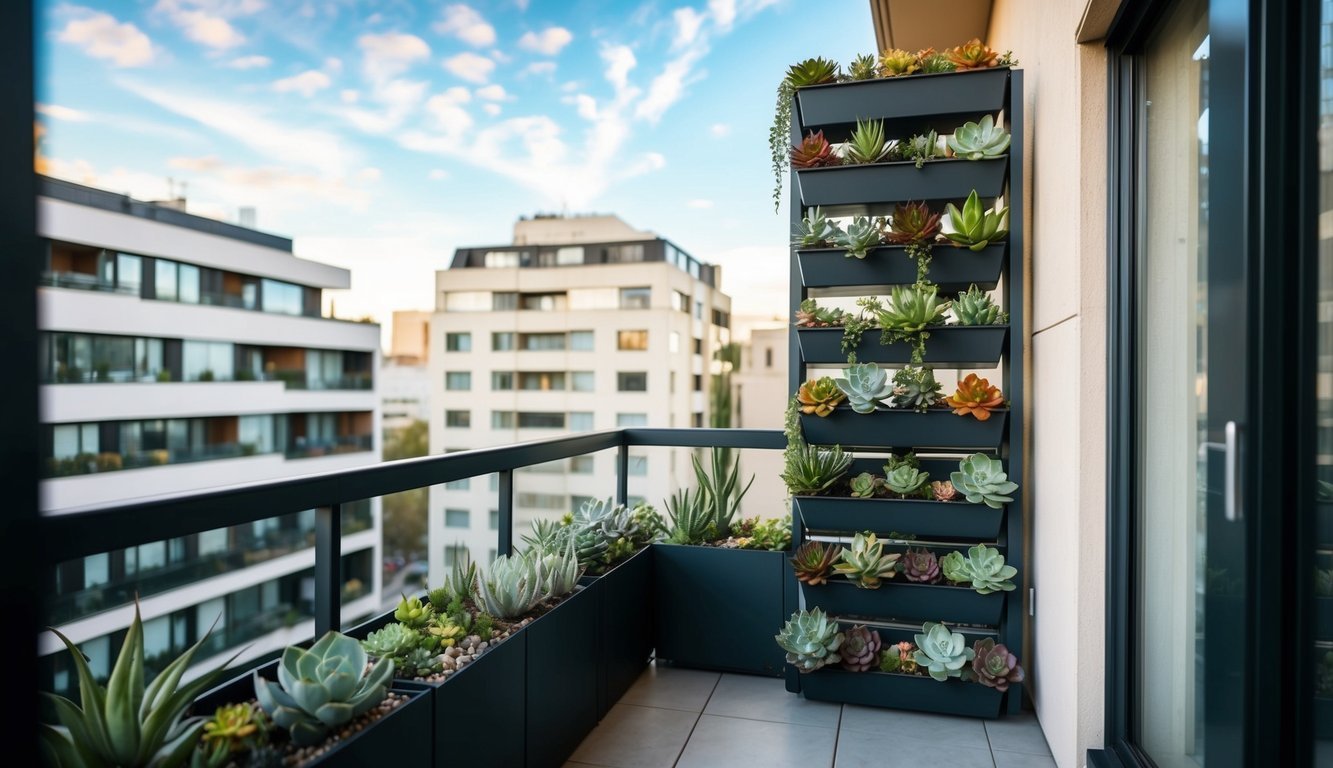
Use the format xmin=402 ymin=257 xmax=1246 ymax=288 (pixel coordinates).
xmin=39 ymin=601 xmax=235 ymax=768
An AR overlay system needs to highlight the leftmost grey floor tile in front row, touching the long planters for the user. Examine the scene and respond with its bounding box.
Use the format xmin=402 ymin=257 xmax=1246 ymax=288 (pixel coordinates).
xmin=569 ymin=703 xmax=698 ymax=768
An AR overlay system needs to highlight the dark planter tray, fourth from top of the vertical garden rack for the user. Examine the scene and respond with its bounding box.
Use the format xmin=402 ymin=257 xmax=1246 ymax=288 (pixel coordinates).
xmin=796 ymin=325 xmax=1009 ymax=368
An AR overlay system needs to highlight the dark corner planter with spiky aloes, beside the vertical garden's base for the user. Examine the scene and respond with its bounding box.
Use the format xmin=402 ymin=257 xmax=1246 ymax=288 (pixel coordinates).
xmin=653 ymin=451 xmax=794 ymax=676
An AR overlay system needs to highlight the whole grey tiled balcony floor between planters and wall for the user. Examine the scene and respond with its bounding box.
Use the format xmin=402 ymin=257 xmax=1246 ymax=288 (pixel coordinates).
xmin=565 ymin=665 xmax=1056 ymax=768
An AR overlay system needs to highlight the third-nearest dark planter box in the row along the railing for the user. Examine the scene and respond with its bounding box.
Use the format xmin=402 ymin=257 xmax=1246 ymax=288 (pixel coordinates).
xmin=522 ymin=579 xmax=603 ymax=767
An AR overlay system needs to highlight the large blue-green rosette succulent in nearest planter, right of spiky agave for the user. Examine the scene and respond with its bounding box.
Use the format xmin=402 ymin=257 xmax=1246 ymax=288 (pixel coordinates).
xmin=255 ymin=631 xmax=393 ymax=747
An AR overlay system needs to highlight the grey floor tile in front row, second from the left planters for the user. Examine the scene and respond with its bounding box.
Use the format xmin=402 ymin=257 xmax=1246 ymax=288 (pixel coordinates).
xmin=676 ymin=715 xmax=837 ymax=768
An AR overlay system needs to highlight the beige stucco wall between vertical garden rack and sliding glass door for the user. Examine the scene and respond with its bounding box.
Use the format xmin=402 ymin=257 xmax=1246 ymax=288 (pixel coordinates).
xmin=989 ymin=0 xmax=1114 ymax=768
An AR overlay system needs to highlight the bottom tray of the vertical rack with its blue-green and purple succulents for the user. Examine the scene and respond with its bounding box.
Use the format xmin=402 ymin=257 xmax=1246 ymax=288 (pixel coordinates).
xmin=774 ymin=608 xmax=1024 ymax=717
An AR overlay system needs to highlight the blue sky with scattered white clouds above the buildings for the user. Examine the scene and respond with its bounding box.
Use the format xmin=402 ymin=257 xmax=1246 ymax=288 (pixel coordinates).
xmin=37 ymin=0 xmax=874 ymax=341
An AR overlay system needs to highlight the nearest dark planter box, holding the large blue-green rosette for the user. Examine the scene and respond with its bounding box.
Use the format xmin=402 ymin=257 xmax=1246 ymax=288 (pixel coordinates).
xmin=193 ymin=661 xmax=435 ymax=768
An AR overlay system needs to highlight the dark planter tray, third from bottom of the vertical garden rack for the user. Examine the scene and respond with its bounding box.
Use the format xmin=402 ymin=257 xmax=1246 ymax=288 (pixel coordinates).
xmin=792 ymin=496 xmax=1004 ymax=541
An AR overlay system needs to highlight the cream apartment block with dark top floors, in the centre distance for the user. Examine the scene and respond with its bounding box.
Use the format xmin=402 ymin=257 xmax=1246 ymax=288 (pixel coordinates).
xmin=429 ymin=216 xmax=730 ymax=583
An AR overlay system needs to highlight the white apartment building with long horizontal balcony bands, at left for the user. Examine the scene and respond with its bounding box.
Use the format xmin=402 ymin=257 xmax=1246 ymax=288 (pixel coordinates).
xmin=39 ymin=179 xmax=380 ymax=689
